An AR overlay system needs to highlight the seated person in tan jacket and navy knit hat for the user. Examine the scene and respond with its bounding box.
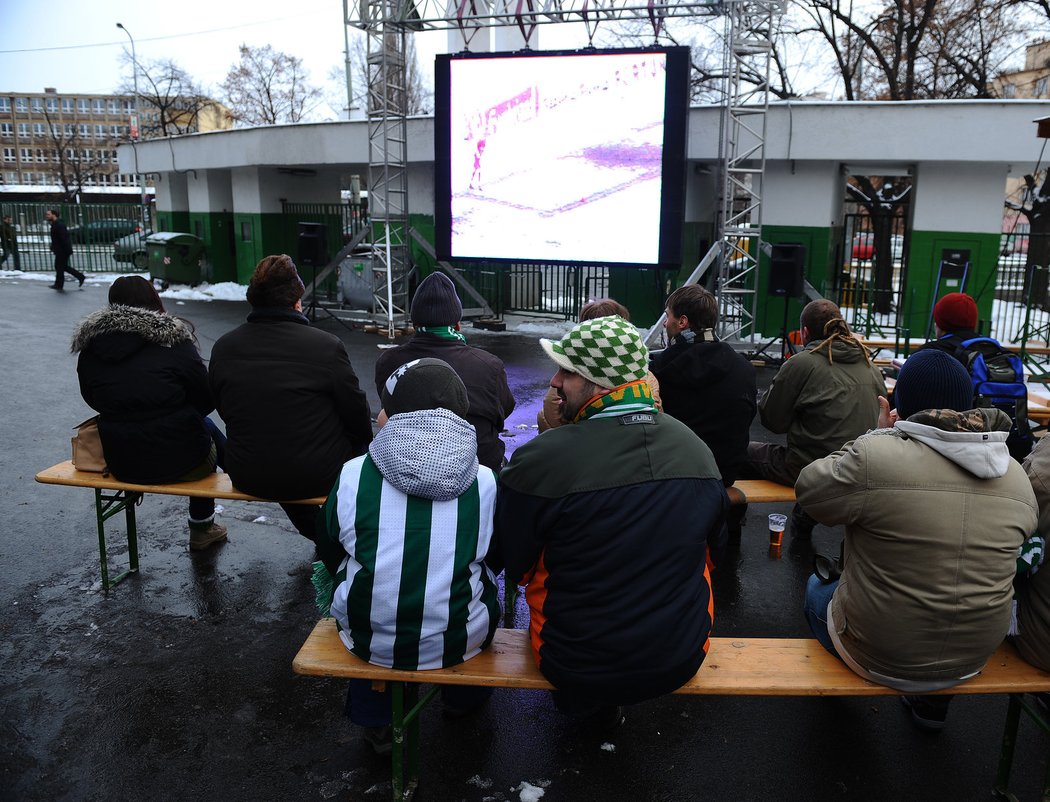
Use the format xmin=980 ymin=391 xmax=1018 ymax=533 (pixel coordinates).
xmin=795 ymin=351 xmax=1036 ymax=729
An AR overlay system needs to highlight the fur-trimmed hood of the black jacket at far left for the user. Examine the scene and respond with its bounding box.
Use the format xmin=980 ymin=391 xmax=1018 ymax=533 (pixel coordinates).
xmin=69 ymin=304 xmax=193 ymax=360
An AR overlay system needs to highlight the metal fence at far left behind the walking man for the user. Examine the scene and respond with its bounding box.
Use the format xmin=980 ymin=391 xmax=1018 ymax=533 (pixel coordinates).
xmin=0 ymin=202 xmax=149 ymax=273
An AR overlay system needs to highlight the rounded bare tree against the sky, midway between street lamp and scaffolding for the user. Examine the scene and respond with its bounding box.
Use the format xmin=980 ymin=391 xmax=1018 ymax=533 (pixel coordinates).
xmin=221 ymin=44 xmax=322 ymax=125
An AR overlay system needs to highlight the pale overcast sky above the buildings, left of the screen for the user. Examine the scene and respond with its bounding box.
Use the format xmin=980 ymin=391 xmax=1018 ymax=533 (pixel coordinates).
xmin=0 ymin=0 xmax=586 ymax=119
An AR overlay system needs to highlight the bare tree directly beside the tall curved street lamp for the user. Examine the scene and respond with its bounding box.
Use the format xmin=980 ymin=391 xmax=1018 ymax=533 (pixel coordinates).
xmin=120 ymin=57 xmax=215 ymax=140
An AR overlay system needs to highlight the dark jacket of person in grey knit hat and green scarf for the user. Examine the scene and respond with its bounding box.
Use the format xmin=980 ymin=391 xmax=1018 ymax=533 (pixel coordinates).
xmin=376 ymin=332 xmax=515 ymax=471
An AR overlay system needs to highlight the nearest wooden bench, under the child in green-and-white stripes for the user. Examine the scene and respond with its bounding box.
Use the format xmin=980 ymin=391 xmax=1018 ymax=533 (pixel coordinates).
xmin=292 ymin=618 xmax=1050 ymax=800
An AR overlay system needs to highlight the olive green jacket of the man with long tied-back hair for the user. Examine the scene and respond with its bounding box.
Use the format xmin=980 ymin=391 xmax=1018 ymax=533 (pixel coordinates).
xmin=758 ymin=340 xmax=886 ymax=473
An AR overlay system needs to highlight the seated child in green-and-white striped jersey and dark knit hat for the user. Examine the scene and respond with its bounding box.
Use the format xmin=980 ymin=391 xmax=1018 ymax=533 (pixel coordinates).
xmin=315 ymin=359 xmax=500 ymax=754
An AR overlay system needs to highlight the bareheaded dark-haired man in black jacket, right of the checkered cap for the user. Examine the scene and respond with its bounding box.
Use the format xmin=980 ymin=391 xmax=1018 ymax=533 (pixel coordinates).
xmin=650 ymin=284 xmax=757 ymax=487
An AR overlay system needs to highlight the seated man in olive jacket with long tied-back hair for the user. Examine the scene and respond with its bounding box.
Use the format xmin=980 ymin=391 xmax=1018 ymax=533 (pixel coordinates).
xmin=740 ymin=299 xmax=886 ymax=537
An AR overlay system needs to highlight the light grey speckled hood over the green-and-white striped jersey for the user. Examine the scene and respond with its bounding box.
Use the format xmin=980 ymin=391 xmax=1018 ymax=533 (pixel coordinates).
xmin=369 ymin=409 xmax=478 ymax=501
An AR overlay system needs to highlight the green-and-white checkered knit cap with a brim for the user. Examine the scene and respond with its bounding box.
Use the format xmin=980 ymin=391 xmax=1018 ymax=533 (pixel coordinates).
xmin=540 ymin=315 xmax=649 ymax=389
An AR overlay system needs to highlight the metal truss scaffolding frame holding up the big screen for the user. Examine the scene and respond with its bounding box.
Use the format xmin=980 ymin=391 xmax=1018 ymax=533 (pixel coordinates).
xmin=343 ymin=0 xmax=785 ymax=337
